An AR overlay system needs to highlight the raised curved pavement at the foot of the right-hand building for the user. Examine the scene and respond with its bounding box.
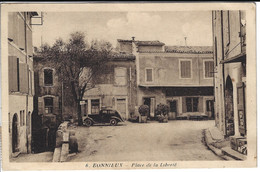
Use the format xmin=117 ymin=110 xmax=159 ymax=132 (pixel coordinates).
xmin=203 ymin=127 xmax=246 ymax=161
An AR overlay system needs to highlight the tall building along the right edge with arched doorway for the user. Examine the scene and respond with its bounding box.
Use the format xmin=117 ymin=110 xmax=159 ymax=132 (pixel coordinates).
xmin=212 ymin=11 xmax=247 ymax=142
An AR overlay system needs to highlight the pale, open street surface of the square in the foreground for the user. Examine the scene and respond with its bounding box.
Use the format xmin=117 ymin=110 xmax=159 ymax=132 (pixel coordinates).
xmin=69 ymin=120 xmax=221 ymax=162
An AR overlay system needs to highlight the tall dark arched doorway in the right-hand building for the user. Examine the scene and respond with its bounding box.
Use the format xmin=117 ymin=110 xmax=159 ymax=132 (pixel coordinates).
xmin=225 ymin=75 xmax=235 ymax=136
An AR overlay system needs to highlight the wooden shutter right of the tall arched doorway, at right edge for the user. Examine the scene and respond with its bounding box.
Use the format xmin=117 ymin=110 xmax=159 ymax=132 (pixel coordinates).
xmin=237 ymin=82 xmax=246 ymax=135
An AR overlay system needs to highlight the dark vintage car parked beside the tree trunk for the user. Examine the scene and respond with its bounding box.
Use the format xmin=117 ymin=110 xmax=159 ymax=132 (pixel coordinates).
xmin=83 ymin=109 xmax=124 ymax=127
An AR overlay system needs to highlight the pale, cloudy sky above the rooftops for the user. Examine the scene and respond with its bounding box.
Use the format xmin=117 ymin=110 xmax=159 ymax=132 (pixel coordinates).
xmin=33 ymin=11 xmax=212 ymax=47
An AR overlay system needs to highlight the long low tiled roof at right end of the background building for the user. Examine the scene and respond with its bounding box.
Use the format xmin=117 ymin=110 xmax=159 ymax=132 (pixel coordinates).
xmin=165 ymin=46 xmax=213 ymax=54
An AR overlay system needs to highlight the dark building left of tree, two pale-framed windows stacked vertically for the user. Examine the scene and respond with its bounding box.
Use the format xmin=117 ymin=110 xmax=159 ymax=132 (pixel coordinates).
xmin=32 ymin=52 xmax=62 ymax=152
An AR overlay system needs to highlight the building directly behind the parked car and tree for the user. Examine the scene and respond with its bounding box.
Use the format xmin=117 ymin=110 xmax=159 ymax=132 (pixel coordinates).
xmin=81 ymin=53 xmax=136 ymax=119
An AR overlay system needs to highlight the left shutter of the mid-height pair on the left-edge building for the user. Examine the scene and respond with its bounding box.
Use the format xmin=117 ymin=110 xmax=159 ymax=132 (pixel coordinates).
xmin=8 ymin=56 xmax=19 ymax=92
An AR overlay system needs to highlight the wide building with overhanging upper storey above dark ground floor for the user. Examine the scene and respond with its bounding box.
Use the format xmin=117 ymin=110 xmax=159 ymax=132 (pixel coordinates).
xmin=118 ymin=38 xmax=214 ymax=119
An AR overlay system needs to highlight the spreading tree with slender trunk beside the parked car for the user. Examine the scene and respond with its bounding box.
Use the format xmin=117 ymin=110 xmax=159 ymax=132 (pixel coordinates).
xmin=36 ymin=32 xmax=113 ymax=125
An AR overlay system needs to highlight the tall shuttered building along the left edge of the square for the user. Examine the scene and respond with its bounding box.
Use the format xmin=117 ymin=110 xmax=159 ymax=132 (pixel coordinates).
xmin=8 ymin=12 xmax=38 ymax=157
